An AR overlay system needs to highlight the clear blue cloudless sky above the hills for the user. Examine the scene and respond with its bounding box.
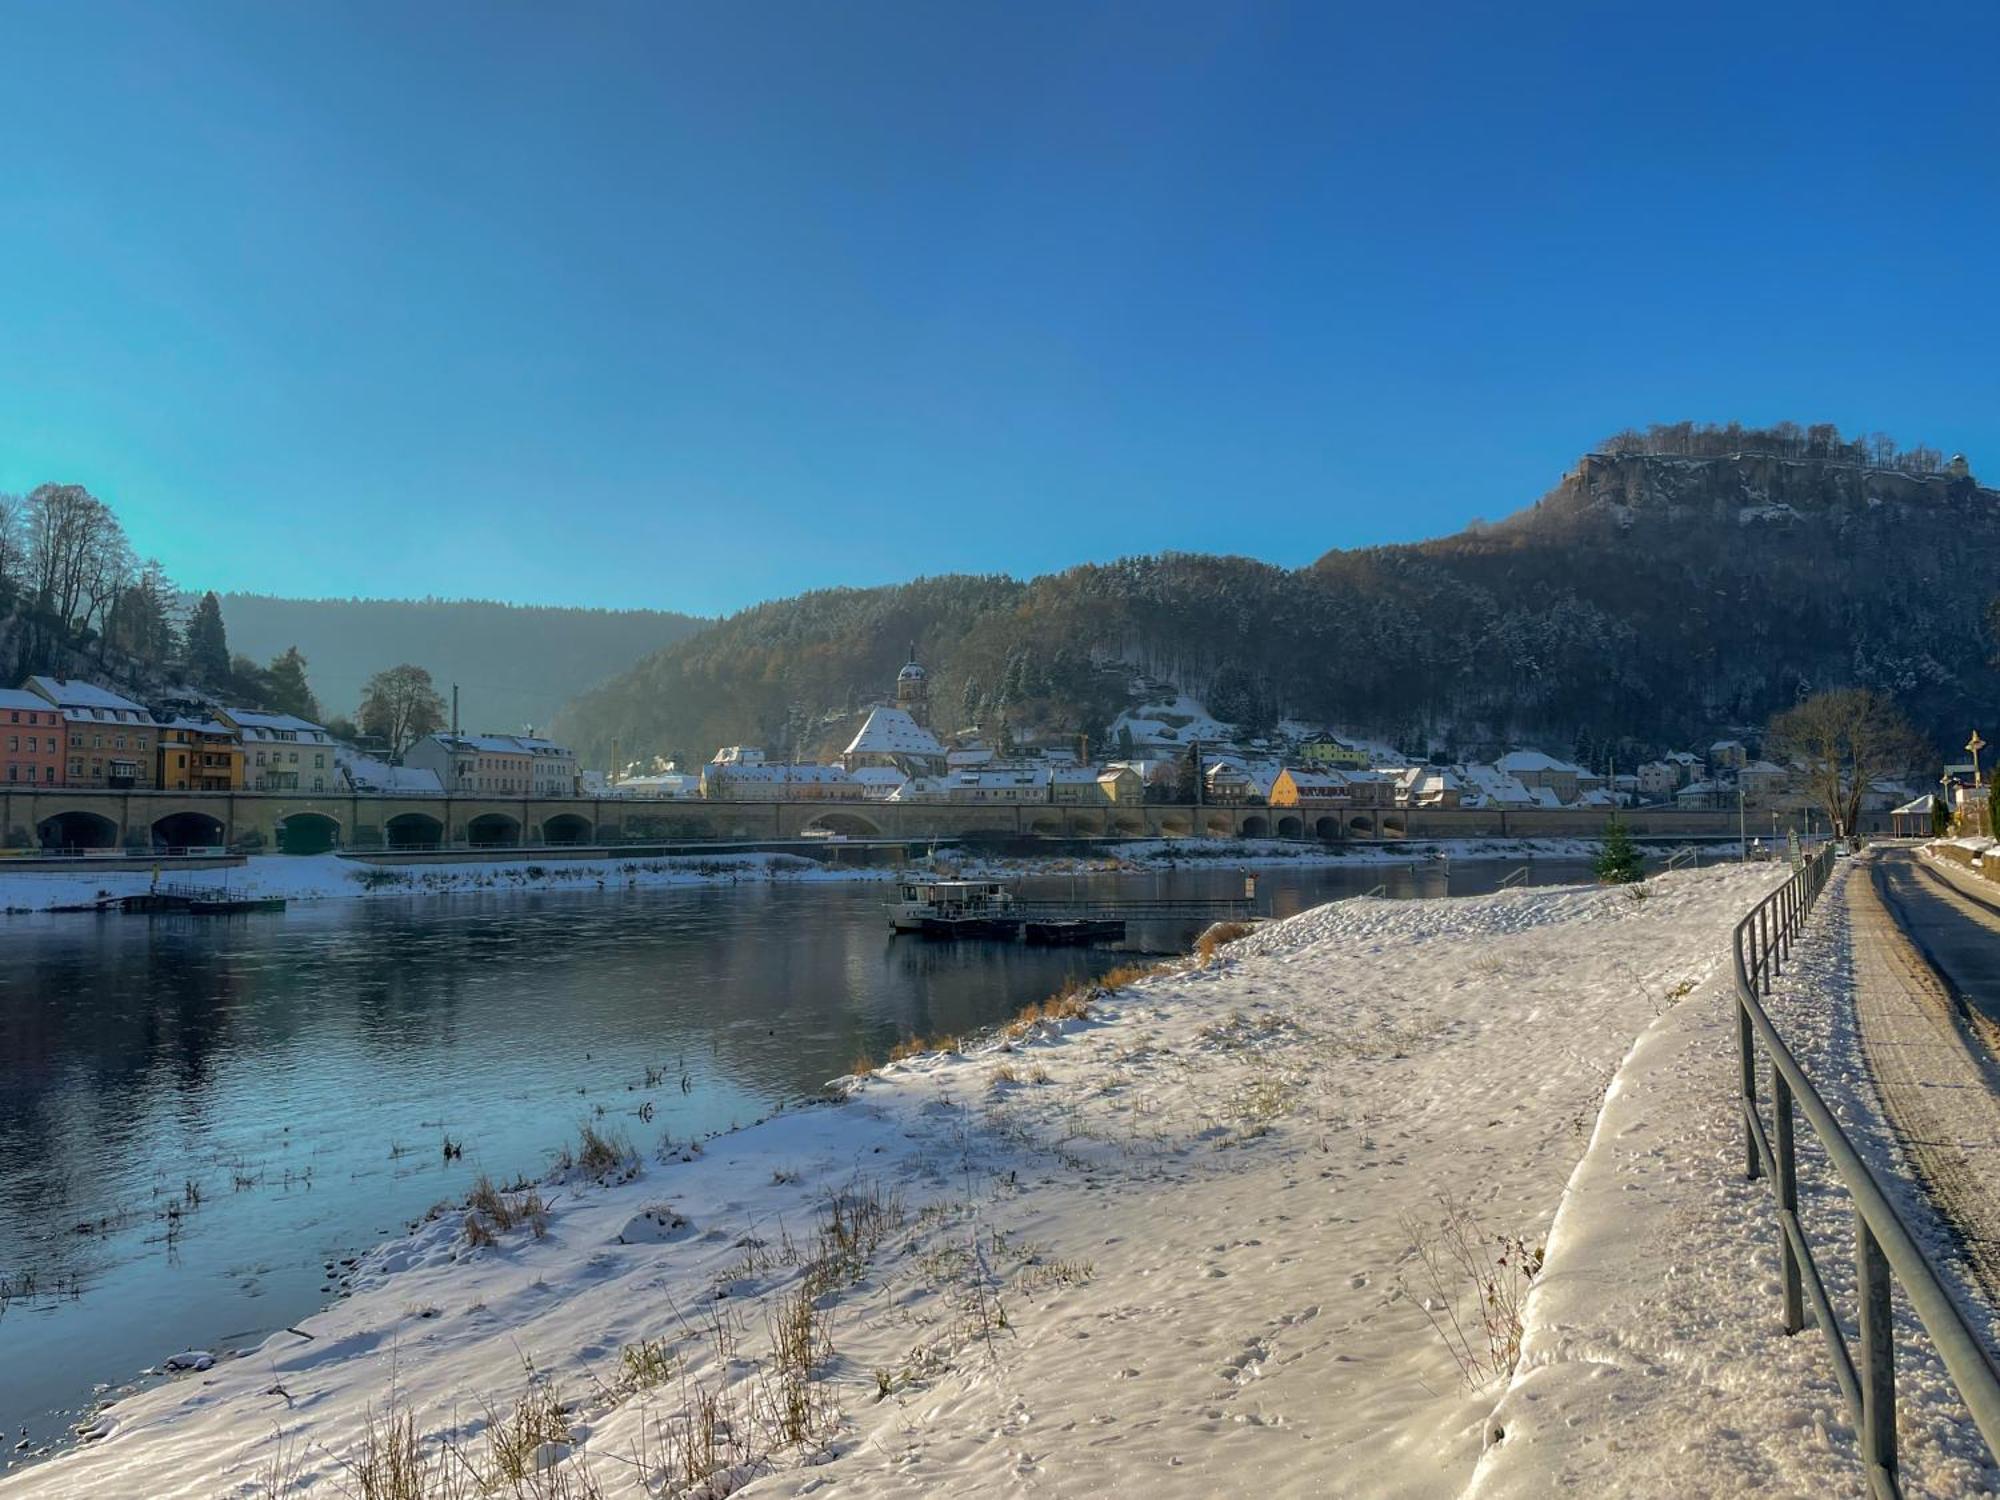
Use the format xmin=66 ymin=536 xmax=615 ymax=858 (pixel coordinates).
xmin=0 ymin=0 xmax=2000 ymax=612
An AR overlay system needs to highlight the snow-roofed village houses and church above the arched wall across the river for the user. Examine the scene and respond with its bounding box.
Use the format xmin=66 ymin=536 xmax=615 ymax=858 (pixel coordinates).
xmin=0 ymin=650 xmax=1908 ymax=836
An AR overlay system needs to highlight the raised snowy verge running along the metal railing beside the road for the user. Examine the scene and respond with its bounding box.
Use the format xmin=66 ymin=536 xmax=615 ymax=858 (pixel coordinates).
xmin=1472 ymin=864 xmax=2000 ymax=1500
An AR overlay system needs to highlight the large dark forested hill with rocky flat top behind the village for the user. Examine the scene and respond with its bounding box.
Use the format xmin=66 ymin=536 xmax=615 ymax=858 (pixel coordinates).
xmin=558 ymin=428 xmax=2000 ymax=762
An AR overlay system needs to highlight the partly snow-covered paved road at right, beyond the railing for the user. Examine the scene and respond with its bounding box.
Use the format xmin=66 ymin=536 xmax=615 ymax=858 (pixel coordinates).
xmin=1844 ymin=850 xmax=2000 ymax=1296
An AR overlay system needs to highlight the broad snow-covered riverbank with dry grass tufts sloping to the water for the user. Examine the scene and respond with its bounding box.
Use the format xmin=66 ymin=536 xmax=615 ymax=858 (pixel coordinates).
xmin=0 ymin=866 xmax=1842 ymax=1500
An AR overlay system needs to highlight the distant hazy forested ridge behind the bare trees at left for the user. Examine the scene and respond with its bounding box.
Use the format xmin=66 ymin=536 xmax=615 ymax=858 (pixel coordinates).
xmin=222 ymin=594 xmax=706 ymax=730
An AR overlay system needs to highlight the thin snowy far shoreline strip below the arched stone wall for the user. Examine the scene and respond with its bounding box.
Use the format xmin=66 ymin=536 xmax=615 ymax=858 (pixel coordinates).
xmin=0 ymin=838 xmax=1632 ymax=916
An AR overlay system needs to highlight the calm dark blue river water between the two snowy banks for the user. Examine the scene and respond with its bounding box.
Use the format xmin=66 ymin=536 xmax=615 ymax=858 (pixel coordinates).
xmin=0 ymin=860 xmax=1588 ymax=1466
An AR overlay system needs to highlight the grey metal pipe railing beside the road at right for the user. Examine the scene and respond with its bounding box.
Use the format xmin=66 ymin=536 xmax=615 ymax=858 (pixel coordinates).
xmin=1734 ymin=848 xmax=2000 ymax=1500
